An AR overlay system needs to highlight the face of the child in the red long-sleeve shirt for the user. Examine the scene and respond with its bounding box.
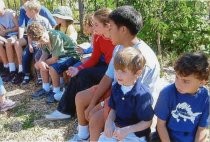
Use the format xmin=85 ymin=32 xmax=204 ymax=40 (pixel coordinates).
xmin=93 ymin=17 xmax=110 ymax=37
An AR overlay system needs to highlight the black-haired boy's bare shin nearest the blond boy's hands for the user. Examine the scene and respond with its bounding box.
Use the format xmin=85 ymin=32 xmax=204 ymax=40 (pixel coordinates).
xmin=89 ymin=106 xmax=105 ymax=141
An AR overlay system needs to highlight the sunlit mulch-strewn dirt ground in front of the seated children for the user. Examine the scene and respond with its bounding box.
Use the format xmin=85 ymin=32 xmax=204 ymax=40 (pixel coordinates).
xmin=0 ymin=68 xmax=209 ymax=142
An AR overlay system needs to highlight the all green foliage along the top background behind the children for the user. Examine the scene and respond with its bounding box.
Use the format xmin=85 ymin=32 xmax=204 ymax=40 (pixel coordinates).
xmin=2 ymin=0 xmax=210 ymax=55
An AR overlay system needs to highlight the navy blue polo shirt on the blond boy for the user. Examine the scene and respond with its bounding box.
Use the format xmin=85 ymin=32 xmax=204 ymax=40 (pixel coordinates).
xmin=109 ymin=80 xmax=154 ymax=137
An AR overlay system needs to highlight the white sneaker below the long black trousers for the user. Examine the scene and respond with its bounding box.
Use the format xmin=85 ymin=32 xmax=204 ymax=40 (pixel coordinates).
xmin=45 ymin=110 xmax=71 ymax=120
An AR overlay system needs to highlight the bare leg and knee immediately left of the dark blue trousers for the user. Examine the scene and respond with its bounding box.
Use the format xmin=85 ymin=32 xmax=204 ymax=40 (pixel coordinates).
xmin=14 ymin=38 xmax=27 ymax=65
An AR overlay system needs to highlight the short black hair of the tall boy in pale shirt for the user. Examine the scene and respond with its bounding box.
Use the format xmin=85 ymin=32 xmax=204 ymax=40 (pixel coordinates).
xmin=109 ymin=6 xmax=143 ymax=35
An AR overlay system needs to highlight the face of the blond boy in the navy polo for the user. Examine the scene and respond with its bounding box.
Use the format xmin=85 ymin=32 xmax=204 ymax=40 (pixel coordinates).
xmin=115 ymin=68 xmax=139 ymax=86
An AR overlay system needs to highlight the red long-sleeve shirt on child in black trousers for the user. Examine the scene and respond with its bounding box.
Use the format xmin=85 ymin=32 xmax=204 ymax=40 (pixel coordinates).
xmin=77 ymin=35 xmax=115 ymax=70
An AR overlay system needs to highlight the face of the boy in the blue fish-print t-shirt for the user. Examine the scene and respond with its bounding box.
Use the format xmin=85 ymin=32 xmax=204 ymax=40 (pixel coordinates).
xmin=175 ymin=74 xmax=205 ymax=94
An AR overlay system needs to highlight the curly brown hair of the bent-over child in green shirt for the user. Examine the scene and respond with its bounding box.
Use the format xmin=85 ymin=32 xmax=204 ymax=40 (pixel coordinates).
xmin=27 ymin=22 xmax=46 ymax=41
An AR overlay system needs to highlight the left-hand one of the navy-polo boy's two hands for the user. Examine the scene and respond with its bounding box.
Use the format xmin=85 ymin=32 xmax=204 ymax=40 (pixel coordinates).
xmin=104 ymin=119 xmax=115 ymax=138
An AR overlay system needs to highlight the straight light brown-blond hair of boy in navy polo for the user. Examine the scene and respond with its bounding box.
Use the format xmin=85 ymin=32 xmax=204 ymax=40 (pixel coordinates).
xmin=114 ymin=47 xmax=146 ymax=74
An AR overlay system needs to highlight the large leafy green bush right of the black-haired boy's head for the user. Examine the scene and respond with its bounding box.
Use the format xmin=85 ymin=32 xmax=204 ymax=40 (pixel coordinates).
xmin=135 ymin=1 xmax=210 ymax=54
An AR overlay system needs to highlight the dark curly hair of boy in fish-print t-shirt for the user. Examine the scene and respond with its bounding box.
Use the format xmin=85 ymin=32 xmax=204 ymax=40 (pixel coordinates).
xmin=174 ymin=53 xmax=210 ymax=80
